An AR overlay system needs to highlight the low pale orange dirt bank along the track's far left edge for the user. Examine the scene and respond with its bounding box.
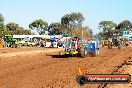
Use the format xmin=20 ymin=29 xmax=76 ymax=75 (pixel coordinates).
xmin=0 ymin=48 xmax=63 ymax=57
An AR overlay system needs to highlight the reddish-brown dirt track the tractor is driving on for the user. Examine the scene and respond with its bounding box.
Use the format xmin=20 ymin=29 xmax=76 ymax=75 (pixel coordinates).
xmin=0 ymin=48 xmax=132 ymax=88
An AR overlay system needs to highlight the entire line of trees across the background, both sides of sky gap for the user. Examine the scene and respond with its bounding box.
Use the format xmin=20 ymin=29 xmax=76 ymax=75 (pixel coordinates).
xmin=0 ymin=12 xmax=132 ymax=39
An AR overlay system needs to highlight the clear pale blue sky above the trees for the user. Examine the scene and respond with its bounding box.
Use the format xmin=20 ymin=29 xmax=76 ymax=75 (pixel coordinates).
xmin=0 ymin=0 xmax=132 ymax=34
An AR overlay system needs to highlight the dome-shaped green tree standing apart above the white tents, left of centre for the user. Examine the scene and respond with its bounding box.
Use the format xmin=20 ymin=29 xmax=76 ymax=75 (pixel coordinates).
xmin=29 ymin=19 xmax=48 ymax=34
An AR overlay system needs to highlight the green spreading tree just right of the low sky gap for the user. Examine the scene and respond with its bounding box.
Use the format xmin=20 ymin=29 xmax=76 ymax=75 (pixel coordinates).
xmin=99 ymin=21 xmax=117 ymax=38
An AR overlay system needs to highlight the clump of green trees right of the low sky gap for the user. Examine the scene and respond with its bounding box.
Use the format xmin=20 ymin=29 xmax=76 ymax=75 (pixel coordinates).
xmin=97 ymin=20 xmax=132 ymax=39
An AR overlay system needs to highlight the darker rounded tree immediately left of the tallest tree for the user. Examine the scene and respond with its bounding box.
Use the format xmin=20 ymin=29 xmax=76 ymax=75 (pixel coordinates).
xmin=49 ymin=22 xmax=63 ymax=35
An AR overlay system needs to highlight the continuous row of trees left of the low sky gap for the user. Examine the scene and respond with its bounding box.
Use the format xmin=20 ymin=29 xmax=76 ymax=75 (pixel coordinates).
xmin=0 ymin=12 xmax=93 ymax=37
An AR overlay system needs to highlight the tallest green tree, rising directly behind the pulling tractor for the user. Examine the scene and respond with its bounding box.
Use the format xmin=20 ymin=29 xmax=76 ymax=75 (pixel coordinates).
xmin=61 ymin=12 xmax=85 ymax=35
